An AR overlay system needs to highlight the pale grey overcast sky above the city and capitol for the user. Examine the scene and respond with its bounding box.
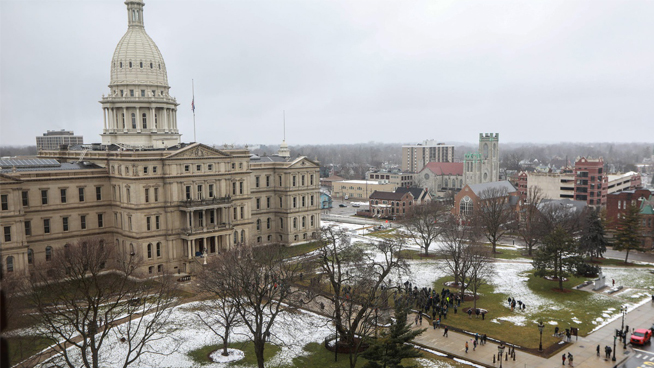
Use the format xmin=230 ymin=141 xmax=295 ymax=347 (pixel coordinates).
xmin=0 ymin=0 xmax=654 ymax=145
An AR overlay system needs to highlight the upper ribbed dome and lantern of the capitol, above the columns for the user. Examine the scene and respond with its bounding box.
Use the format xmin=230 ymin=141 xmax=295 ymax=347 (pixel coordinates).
xmin=109 ymin=0 xmax=168 ymax=87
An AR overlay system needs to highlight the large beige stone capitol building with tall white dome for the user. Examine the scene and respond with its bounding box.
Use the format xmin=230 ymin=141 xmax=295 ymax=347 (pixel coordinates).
xmin=0 ymin=0 xmax=320 ymax=276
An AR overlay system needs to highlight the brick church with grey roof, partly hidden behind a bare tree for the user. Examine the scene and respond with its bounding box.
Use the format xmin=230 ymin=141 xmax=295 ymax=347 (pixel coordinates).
xmin=452 ymin=181 xmax=522 ymax=216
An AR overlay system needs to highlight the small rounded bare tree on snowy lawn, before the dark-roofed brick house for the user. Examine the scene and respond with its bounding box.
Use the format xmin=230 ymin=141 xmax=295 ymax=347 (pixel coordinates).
xmin=402 ymin=201 xmax=446 ymax=256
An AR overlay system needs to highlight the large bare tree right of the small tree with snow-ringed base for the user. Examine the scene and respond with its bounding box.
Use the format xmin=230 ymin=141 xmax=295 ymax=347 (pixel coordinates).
xmin=203 ymin=245 xmax=304 ymax=368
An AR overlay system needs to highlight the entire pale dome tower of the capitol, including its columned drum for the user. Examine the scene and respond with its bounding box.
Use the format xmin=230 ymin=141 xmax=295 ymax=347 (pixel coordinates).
xmin=100 ymin=0 xmax=181 ymax=148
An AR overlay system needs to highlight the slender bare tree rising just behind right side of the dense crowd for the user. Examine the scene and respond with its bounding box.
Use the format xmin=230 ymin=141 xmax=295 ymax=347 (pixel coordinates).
xmin=439 ymin=215 xmax=479 ymax=299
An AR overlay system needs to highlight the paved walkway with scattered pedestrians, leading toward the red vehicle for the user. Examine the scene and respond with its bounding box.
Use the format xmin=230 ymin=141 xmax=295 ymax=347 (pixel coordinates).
xmin=409 ymin=302 xmax=654 ymax=368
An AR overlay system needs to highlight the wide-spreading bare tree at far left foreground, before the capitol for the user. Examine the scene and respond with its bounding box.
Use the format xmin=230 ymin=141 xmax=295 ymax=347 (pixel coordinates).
xmin=24 ymin=238 xmax=175 ymax=368
